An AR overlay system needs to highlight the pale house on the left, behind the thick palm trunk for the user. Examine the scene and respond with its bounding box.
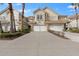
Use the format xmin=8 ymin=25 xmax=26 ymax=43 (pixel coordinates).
xmin=0 ymin=8 xmax=26 ymax=32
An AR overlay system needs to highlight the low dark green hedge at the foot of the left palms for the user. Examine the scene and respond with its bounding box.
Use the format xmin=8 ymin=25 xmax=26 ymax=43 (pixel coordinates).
xmin=0 ymin=27 xmax=31 ymax=38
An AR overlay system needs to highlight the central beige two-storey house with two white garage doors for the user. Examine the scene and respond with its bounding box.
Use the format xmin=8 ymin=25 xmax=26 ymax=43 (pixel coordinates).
xmin=31 ymin=7 xmax=67 ymax=31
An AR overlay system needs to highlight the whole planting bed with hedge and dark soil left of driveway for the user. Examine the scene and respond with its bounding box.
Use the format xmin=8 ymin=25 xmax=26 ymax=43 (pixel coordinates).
xmin=0 ymin=29 xmax=30 ymax=40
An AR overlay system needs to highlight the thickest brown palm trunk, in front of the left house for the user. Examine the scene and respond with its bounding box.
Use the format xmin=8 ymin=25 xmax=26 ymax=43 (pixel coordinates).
xmin=8 ymin=3 xmax=16 ymax=32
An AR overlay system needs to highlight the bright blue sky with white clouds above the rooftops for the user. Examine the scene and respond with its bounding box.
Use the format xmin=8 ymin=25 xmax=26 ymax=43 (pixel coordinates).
xmin=0 ymin=3 xmax=78 ymax=16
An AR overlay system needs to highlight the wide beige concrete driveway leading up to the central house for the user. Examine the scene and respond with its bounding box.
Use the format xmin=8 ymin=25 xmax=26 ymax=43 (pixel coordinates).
xmin=0 ymin=32 xmax=79 ymax=56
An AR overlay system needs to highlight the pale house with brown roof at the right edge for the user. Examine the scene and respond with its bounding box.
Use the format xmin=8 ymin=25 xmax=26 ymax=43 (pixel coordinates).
xmin=68 ymin=14 xmax=79 ymax=28
